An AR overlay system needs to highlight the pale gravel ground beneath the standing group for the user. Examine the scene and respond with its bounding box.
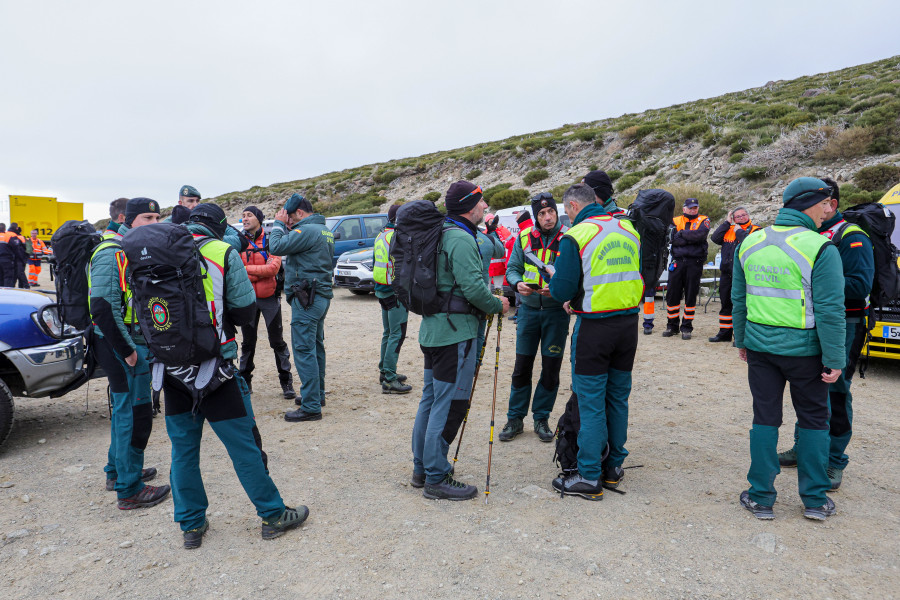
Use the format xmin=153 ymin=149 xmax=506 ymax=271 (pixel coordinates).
xmin=0 ymin=273 xmax=900 ymax=600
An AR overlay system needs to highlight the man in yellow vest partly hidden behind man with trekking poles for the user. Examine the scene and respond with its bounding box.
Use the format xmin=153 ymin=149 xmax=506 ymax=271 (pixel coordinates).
xmin=372 ymin=204 xmax=412 ymax=394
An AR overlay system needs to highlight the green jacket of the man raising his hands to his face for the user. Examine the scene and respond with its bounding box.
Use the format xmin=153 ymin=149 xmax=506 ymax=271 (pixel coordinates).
xmin=269 ymin=214 xmax=334 ymax=298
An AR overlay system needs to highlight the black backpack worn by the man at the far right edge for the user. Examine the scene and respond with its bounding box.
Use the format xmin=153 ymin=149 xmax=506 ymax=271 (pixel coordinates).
xmin=831 ymin=202 xmax=900 ymax=307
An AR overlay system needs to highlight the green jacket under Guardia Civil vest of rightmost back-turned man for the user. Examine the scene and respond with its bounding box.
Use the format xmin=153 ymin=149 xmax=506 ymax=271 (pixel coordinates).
xmin=731 ymin=208 xmax=846 ymax=369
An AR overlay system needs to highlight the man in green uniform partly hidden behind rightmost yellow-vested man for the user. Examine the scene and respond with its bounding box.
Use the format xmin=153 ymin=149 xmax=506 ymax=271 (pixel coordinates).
xmin=778 ymin=178 xmax=875 ymax=490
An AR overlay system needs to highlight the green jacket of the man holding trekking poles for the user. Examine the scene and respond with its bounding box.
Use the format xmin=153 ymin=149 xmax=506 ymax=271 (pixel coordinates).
xmin=419 ymin=222 xmax=503 ymax=348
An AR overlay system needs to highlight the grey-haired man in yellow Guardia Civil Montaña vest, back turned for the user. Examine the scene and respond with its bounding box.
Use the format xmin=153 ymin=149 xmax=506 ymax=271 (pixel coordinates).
xmin=550 ymin=183 xmax=644 ymax=500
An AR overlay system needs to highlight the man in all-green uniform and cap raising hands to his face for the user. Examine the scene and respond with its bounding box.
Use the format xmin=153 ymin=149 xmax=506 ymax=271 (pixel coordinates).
xmin=269 ymin=194 xmax=334 ymax=422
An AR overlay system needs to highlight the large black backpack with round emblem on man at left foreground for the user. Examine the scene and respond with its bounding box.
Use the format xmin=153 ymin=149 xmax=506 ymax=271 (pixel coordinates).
xmin=121 ymin=223 xmax=220 ymax=367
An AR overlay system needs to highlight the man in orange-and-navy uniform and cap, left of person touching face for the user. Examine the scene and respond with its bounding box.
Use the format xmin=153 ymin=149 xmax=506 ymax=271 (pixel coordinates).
xmin=662 ymin=198 xmax=709 ymax=340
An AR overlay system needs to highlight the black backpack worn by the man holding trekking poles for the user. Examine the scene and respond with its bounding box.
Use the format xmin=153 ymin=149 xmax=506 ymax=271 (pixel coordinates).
xmin=390 ymin=200 xmax=448 ymax=315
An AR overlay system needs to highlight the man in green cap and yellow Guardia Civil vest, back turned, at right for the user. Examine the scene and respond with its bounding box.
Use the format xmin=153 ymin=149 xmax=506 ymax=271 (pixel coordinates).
xmin=731 ymin=177 xmax=846 ymax=521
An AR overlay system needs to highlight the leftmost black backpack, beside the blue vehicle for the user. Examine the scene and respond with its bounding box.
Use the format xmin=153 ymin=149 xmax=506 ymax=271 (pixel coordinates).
xmin=50 ymin=221 xmax=103 ymax=330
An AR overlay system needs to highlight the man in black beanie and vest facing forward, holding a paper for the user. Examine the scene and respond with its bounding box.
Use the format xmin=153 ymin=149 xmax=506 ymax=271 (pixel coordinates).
xmin=500 ymin=192 xmax=569 ymax=442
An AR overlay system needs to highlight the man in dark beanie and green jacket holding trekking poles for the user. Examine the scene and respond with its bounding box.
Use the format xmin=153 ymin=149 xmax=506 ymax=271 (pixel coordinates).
xmin=411 ymin=181 xmax=509 ymax=500
